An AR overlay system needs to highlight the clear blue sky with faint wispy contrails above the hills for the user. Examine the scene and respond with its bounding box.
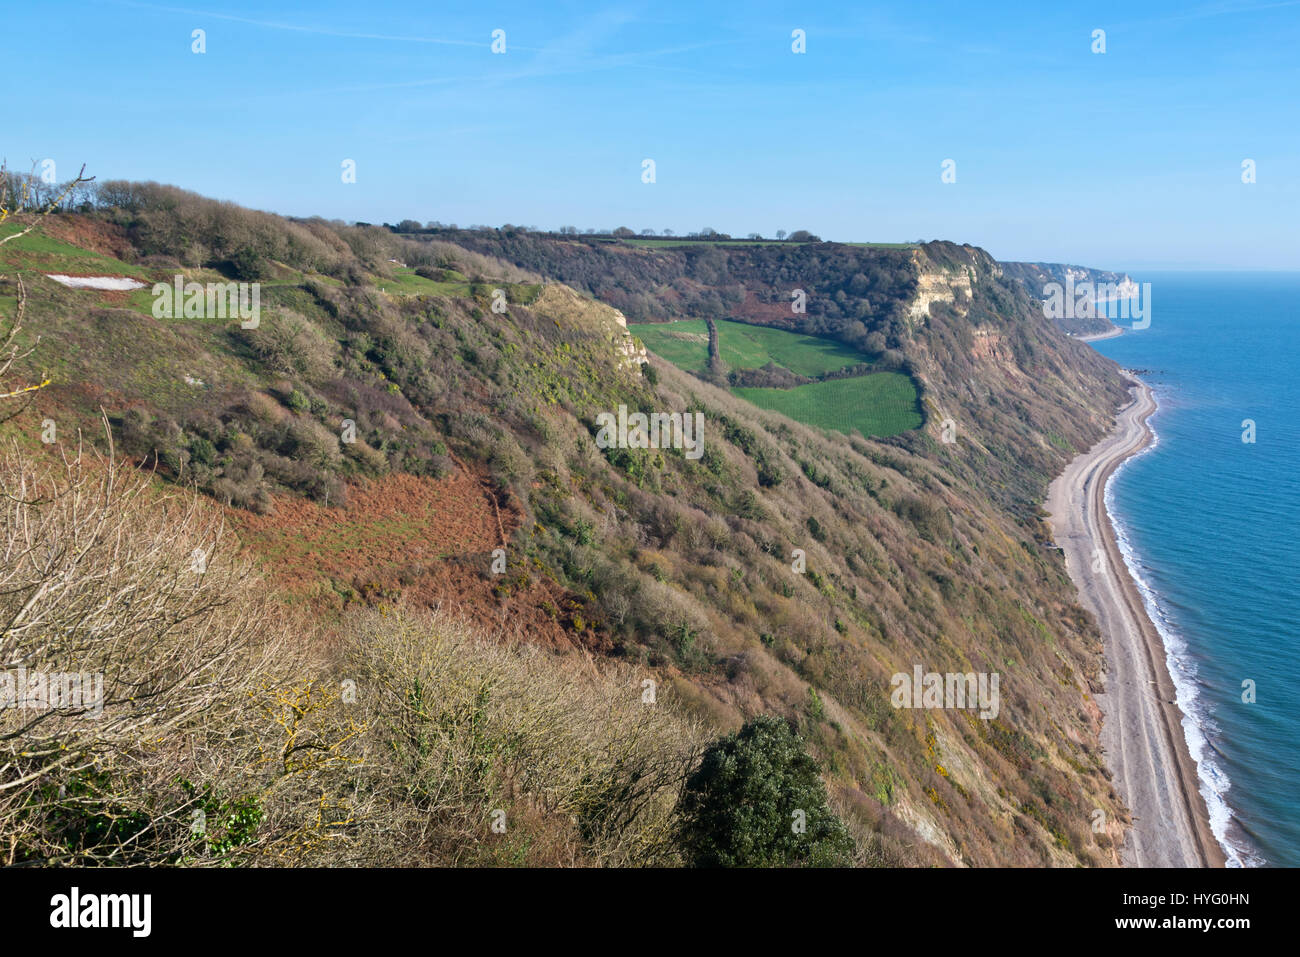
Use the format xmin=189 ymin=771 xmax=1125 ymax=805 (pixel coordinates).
xmin=10 ymin=0 xmax=1300 ymax=270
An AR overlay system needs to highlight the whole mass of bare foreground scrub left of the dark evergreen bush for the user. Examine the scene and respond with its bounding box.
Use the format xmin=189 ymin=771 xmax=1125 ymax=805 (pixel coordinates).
xmin=0 ymin=452 xmax=759 ymax=866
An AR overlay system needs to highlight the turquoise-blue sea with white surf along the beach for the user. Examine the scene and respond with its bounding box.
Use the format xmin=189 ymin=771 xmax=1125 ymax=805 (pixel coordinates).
xmin=1093 ymin=273 xmax=1300 ymax=867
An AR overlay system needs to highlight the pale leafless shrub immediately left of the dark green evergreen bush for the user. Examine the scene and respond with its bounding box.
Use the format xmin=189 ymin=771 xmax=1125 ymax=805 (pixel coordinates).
xmin=343 ymin=609 xmax=702 ymax=866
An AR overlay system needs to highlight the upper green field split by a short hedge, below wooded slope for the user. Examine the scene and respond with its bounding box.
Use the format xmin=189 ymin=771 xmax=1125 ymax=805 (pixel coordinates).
xmin=628 ymin=319 xmax=870 ymax=378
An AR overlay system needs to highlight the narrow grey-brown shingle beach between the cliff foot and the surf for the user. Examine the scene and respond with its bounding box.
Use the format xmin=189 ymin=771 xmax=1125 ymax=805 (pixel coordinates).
xmin=1047 ymin=379 xmax=1226 ymax=867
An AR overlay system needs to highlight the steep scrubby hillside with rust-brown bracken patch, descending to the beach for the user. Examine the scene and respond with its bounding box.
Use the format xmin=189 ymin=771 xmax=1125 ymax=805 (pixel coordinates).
xmin=0 ymin=186 xmax=1123 ymax=866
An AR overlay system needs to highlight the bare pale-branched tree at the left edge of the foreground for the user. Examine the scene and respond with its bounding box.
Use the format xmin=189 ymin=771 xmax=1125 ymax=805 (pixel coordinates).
xmin=0 ymin=445 xmax=299 ymax=863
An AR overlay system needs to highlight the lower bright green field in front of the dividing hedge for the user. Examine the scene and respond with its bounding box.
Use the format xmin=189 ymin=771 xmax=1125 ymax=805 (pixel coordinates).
xmin=733 ymin=372 xmax=922 ymax=437
